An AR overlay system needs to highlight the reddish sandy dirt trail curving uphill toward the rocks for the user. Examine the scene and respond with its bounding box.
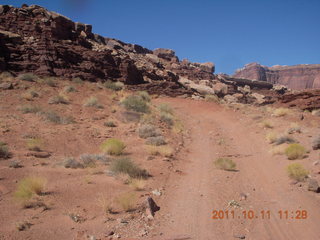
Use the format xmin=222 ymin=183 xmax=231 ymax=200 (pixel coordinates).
xmin=156 ymin=98 xmax=320 ymax=240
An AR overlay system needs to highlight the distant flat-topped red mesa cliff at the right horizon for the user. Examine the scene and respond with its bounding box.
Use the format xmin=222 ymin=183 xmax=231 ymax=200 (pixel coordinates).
xmin=233 ymin=63 xmax=320 ymax=90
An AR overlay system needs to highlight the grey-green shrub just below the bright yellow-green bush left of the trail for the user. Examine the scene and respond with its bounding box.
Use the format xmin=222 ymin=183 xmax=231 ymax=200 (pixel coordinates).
xmin=110 ymin=158 xmax=149 ymax=178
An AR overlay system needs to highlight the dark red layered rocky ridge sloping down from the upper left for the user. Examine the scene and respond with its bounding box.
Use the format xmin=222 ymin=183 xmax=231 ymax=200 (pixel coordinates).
xmin=0 ymin=5 xmax=218 ymax=95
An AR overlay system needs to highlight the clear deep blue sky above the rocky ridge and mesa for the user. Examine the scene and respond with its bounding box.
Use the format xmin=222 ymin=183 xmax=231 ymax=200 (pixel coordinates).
xmin=0 ymin=0 xmax=320 ymax=74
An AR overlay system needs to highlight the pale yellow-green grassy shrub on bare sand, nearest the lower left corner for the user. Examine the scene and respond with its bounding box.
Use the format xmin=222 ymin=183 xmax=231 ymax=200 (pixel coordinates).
xmin=14 ymin=176 xmax=47 ymax=202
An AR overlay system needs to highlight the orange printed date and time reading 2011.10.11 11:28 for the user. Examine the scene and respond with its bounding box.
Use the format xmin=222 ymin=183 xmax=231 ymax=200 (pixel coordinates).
xmin=211 ymin=210 xmax=308 ymax=220
